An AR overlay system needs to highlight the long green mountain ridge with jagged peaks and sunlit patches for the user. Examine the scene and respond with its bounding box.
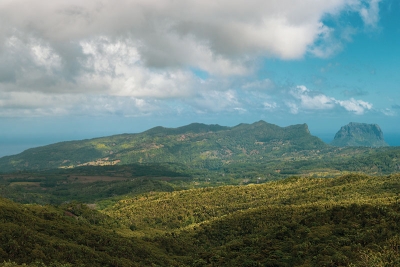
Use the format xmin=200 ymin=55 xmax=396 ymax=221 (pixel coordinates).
xmin=0 ymin=121 xmax=327 ymax=172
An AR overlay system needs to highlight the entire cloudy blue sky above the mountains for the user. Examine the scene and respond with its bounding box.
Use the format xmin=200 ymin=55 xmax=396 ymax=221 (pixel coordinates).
xmin=0 ymin=0 xmax=400 ymax=156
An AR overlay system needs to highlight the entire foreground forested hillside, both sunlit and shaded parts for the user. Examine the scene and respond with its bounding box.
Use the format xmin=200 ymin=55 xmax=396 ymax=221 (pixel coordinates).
xmin=0 ymin=174 xmax=400 ymax=267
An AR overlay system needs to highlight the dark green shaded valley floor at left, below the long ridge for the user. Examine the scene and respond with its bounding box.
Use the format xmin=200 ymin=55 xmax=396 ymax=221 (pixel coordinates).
xmin=0 ymin=164 xmax=191 ymax=208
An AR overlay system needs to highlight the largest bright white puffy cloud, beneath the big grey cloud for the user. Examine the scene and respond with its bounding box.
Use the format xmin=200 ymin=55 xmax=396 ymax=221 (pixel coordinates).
xmin=81 ymin=37 xmax=195 ymax=99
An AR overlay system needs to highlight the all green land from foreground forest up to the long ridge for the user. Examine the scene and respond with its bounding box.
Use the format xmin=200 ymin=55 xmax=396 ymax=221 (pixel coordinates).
xmin=0 ymin=121 xmax=400 ymax=267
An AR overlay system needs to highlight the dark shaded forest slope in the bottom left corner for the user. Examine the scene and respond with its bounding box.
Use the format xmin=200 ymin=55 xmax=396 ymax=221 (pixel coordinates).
xmin=0 ymin=198 xmax=174 ymax=267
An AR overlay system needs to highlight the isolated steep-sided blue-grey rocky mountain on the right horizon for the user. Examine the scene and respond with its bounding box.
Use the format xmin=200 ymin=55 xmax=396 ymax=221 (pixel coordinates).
xmin=331 ymin=122 xmax=388 ymax=147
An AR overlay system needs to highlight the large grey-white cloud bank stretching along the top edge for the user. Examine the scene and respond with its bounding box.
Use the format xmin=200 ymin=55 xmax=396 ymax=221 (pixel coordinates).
xmin=0 ymin=0 xmax=379 ymax=74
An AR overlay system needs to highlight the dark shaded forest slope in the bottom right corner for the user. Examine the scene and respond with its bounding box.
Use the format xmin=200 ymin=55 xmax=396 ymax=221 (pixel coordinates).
xmin=177 ymin=204 xmax=400 ymax=267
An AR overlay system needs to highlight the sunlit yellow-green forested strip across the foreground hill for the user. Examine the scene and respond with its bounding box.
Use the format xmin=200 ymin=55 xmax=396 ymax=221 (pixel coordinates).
xmin=105 ymin=174 xmax=400 ymax=232
